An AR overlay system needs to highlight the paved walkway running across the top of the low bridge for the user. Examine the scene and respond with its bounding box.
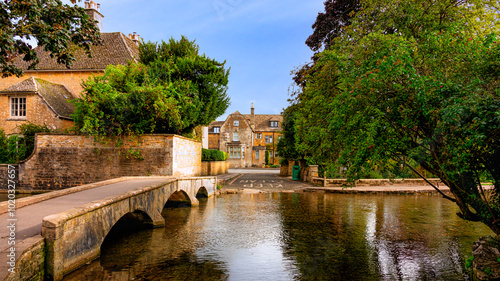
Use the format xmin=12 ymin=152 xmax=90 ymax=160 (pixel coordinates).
xmin=0 ymin=177 xmax=173 ymax=280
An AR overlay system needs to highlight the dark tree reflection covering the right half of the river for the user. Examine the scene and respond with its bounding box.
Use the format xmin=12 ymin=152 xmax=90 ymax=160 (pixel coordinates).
xmin=280 ymin=194 xmax=488 ymax=280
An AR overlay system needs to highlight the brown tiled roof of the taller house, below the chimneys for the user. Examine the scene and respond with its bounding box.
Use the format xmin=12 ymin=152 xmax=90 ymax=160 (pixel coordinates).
xmin=14 ymin=32 xmax=139 ymax=71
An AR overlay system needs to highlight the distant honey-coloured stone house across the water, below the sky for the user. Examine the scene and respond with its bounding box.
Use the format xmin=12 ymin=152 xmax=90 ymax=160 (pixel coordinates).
xmin=208 ymin=104 xmax=283 ymax=168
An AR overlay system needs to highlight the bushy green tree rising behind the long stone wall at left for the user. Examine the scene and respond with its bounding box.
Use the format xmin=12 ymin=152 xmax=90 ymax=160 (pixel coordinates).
xmin=73 ymin=37 xmax=229 ymax=135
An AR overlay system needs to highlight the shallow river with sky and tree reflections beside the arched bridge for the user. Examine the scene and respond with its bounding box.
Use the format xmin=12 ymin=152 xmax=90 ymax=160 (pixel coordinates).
xmin=64 ymin=193 xmax=493 ymax=281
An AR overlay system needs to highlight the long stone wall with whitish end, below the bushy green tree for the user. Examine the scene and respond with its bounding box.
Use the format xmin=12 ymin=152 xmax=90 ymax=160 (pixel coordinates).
xmin=8 ymin=134 xmax=201 ymax=190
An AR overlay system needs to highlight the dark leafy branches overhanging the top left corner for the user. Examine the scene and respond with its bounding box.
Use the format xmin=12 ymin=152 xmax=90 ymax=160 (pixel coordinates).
xmin=0 ymin=0 xmax=100 ymax=77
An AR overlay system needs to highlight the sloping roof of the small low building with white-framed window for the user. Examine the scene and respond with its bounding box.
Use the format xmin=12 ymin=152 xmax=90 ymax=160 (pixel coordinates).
xmin=0 ymin=77 xmax=75 ymax=119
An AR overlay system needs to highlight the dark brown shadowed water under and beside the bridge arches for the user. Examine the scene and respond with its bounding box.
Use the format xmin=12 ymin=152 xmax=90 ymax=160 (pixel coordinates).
xmin=64 ymin=198 xmax=227 ymax=281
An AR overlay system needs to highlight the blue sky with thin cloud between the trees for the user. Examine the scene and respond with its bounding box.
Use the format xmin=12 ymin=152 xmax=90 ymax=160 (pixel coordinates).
xmin=73 ymin=0 xmax=324 ymax=120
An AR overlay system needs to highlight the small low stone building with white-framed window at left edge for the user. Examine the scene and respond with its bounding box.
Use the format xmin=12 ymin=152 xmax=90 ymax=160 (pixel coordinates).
xmin=0 ymin=77 xmax=75 ymax=135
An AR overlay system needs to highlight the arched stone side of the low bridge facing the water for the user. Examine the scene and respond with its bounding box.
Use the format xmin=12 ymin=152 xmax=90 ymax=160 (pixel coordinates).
xmin=42 ymin=177 xmax=216 ymax=280
